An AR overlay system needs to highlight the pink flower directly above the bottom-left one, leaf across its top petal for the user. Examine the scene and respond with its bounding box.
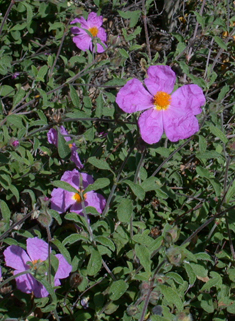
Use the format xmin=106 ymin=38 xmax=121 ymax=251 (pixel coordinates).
xmin=51 ymin=169 xmax=106 ymax=215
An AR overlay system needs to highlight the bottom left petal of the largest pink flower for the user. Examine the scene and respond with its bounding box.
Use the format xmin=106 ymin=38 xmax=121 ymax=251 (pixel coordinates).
xmin=138 ymin=108 xmax=163 ymax=144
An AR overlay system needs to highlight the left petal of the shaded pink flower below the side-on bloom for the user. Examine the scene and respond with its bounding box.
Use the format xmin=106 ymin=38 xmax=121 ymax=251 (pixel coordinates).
xmin=51 ymin=188 xmax=75 ymax=214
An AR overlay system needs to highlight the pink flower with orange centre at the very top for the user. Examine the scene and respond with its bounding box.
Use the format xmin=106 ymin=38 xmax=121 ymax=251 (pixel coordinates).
xmin=71 ymin=12 xmax=107 ymax=53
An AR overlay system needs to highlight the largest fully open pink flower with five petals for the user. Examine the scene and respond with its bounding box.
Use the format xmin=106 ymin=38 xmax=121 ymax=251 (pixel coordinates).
xmin=116 ymin=66 xmax=206 ymax=144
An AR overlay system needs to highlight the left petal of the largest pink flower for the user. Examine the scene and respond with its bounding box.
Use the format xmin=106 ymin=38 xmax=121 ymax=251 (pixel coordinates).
xmin=116 ymin=78 xmax=153 ymax=113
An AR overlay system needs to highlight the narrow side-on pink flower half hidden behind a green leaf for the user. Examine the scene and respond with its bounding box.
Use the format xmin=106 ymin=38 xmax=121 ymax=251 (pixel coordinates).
xmin=47 ymin=126 xmax=83 ymax=169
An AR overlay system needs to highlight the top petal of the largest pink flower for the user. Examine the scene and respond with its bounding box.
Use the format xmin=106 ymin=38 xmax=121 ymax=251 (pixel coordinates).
xmin=144 ymin=66 xmax=176 ymax=96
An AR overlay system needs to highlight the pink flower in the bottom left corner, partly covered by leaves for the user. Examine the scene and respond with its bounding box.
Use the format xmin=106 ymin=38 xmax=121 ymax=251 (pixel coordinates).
xmin=3 ymin=237 xmax=72 ymax=298
